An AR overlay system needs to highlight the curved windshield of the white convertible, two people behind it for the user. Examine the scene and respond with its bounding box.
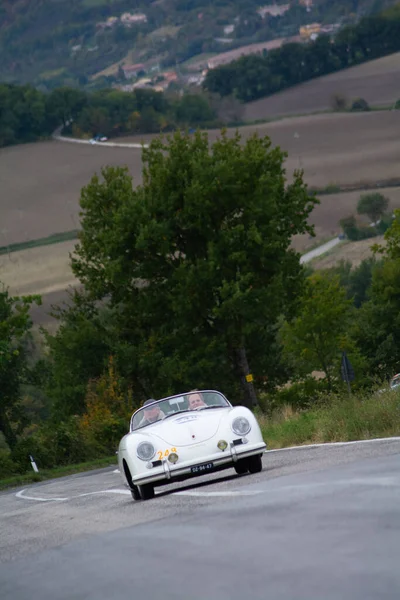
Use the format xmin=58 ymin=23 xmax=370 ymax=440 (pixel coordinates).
xmin=130 ymin=391 xmax=231 ymax=431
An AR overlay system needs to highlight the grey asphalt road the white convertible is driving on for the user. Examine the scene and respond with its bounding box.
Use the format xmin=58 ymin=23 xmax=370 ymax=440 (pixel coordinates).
xmin=0 ymin=440 xmax=400 ymax=600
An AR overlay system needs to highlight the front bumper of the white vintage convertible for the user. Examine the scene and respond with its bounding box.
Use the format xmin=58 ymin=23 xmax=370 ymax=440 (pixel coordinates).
xmin=132 ymin=443 xmax=267 ymax=485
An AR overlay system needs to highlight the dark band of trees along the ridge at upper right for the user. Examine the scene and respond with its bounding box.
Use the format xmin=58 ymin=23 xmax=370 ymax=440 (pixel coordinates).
xmin=203 ymin=13 xmax=400 ymax=102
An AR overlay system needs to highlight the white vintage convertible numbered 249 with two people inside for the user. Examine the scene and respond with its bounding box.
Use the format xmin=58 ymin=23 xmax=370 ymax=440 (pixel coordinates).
xmin=118 ymin=390 xmax=267 ymax=500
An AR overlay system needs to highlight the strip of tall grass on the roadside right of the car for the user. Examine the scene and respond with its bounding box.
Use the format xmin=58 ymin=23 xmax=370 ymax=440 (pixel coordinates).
xmin=259 ymin=391 xmax=400 ymax=448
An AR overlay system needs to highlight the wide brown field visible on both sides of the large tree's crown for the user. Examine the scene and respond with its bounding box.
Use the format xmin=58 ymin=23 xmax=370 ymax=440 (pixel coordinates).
xmin=0 ymin=111 xmax=400 ymax=248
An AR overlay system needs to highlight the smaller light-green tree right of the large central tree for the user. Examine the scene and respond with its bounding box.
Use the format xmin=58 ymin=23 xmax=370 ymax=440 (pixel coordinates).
xmin=281 ymin=273 xmax=354 ymax=389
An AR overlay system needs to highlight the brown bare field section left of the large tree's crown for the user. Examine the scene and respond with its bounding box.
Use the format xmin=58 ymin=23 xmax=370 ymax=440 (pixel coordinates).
xmin=0 ymin=141 xmax=141 ymax=246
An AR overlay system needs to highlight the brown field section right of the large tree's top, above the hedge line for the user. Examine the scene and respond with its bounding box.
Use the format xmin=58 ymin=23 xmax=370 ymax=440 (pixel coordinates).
xmin=121 ymin=109 xmax=400 ymax=189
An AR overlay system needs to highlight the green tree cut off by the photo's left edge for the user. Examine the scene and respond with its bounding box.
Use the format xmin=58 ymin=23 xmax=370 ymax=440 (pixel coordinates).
xmin=0 ymin=288 xmax=40 ymax=448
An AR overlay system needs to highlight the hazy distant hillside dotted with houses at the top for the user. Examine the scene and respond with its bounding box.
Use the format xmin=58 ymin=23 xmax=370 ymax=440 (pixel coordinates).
xmin=0 ymin=0 xmax=393 ymax=89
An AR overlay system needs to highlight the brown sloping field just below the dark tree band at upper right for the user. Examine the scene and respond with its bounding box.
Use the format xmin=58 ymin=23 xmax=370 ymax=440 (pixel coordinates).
xmin=244 ymin=53 xmax=400 ymax=121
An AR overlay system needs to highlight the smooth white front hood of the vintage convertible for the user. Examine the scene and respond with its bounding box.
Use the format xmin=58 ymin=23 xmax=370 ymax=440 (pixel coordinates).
xmin=140 ymin=407 xmax=232 ymax=446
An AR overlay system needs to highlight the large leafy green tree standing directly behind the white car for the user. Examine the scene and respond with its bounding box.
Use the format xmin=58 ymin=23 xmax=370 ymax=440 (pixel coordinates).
xmin=72 ymin=132 xmax=318 ymax=405
